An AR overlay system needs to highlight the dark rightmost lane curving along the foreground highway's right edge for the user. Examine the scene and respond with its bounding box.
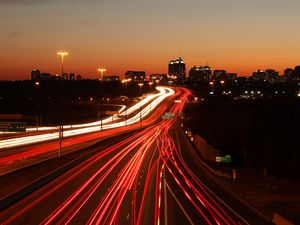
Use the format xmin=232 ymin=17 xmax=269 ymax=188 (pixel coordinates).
xmin=171 ymin=123 xmax=270 ymax=224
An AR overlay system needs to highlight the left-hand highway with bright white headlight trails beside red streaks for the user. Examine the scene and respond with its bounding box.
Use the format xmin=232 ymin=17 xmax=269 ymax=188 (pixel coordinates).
xmin=0 ymin=87 xmax=178 ymax=175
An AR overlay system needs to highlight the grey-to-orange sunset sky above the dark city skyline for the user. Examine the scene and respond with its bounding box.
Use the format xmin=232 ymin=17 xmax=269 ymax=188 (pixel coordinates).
xmin=0 ymin=0 xmax=300 ymax=80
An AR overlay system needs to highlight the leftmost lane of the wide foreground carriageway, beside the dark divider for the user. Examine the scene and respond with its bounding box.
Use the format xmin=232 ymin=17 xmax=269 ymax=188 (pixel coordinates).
xmin=0 ymin=130 xmax=146 ymax=224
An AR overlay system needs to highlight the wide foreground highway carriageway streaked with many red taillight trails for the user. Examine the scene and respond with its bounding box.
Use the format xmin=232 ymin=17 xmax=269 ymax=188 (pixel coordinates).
xmin=0 ymin=88 xmax=268 ymax=225
